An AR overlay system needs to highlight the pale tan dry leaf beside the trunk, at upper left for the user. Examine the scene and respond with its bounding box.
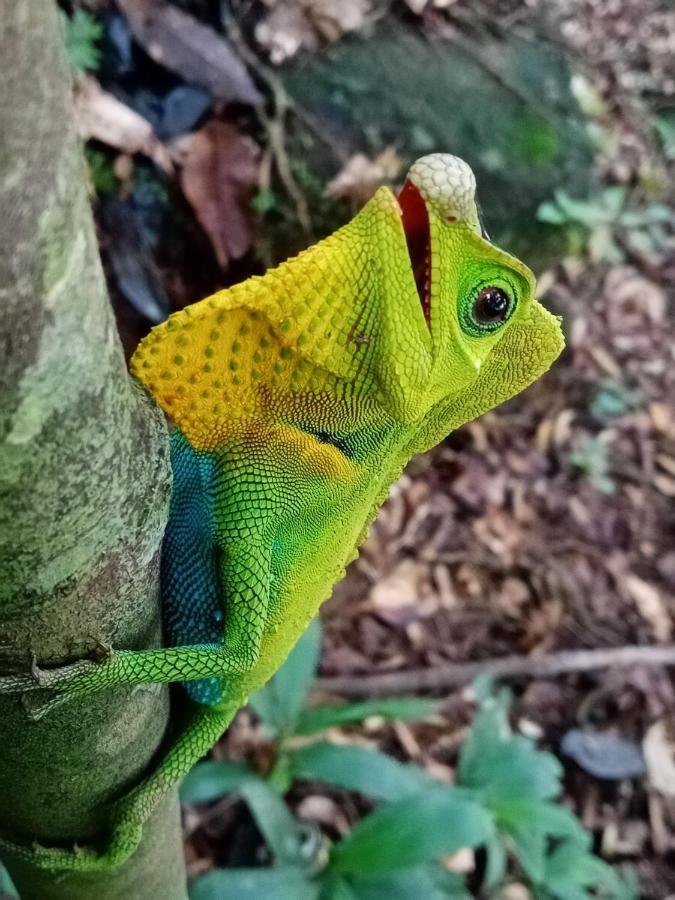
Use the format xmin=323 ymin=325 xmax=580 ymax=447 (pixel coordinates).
xmin=75 ymin=78 xmax=173 ymax=172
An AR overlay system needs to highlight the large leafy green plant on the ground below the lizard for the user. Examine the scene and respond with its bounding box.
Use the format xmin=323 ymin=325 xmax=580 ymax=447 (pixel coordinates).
xmin=181 ymin=623 xmax=633 ymax=900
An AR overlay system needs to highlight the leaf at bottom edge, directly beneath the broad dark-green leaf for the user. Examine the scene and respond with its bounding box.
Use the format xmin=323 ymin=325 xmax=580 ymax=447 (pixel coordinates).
xmin=344 ymin=863 xmax=471 ymax=900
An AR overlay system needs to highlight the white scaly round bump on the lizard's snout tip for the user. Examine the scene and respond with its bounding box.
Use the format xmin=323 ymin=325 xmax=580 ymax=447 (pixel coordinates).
xmin=408 ymin=153 xmax=480 ymax=233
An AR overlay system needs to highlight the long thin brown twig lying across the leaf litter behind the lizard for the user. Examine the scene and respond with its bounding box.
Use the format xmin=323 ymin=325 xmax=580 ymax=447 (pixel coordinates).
xmin=315 ymin=644 xmax=675 ymax=697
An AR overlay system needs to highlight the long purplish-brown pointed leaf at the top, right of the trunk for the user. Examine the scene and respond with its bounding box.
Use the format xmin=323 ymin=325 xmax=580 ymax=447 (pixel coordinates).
xmin=117 ymin=0 xmax=262 ymax=105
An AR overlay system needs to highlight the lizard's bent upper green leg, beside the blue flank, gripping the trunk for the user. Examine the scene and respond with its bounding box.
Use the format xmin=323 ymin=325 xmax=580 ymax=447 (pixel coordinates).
xmin=0 ymin=539 xmax=271 ymax=718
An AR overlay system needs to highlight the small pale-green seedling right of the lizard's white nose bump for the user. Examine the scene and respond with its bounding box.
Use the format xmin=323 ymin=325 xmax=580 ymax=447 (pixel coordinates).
xmin=537 ymin=186 xmax=675 ymax=263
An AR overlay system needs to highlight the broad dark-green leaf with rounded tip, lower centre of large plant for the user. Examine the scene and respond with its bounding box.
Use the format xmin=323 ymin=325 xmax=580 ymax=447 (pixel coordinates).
xmin=329 ymin=787 xmax=492 ymax=876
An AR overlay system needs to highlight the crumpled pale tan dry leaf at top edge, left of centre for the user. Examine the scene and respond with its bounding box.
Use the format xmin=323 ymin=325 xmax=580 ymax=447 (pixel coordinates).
xmin=255 ymin=0 xmax=372 ymax=64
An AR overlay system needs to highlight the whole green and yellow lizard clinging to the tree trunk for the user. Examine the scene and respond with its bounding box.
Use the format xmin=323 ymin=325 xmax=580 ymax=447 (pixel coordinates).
xmin=0 ymin=153 xmax=563 ymax=871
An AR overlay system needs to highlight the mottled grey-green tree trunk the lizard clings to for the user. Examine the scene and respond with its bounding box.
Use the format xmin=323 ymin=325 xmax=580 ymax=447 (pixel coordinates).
xmin=0 ymin=0 xmax=186 ymax=900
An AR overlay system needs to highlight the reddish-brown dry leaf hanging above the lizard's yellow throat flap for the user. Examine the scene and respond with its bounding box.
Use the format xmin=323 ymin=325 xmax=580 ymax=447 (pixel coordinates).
xmin=181 ymin=121 xmax=260 ymax=266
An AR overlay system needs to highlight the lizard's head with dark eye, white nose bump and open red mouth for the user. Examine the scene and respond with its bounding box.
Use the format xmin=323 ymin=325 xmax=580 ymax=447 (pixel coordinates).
xmin=364 ymin=153 xmax=563 ymax=432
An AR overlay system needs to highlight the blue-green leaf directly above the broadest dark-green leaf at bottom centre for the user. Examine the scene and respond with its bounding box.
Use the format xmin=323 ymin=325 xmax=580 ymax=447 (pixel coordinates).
xmin=289 ymin=742 xmax=432 ymax=800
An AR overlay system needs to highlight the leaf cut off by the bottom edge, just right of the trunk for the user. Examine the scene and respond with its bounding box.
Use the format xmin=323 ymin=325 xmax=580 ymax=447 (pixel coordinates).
xmin=188 ymin=867 xmax=319 ymax=900
